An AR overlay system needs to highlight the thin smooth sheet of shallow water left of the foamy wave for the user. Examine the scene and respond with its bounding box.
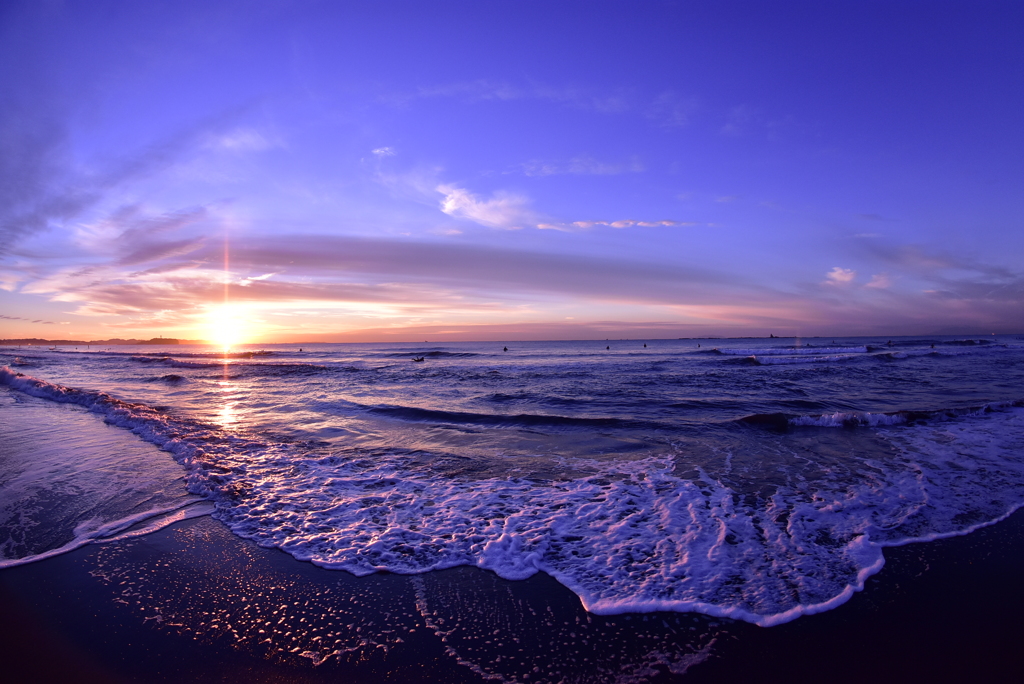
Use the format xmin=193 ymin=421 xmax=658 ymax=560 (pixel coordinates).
xmin=0 ymin=368 xmax=211 ymax=567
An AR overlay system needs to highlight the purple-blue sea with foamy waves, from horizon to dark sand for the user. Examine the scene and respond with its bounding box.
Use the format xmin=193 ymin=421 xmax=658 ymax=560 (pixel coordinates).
xmin=0 ymin=337 xmax=1024 ymax=626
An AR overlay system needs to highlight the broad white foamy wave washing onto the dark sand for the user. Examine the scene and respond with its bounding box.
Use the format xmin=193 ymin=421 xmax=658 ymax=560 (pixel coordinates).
xmin=6 ymin=368 xmax=1024 ymax=626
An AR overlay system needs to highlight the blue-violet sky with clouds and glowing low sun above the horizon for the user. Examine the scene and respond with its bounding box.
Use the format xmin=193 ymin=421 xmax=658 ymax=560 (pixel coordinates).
xmin=0 ymin=0 xmax=1024 ymax=344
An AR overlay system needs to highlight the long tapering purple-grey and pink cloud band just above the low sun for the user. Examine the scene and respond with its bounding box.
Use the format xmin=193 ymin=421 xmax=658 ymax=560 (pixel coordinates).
xmin=23 ymin=228 xmax=770 ymax=322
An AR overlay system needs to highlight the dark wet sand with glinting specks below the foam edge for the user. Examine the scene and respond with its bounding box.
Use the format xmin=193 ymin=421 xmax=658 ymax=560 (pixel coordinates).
xmin=0 ymin=510 xmax=1024 ymax=684
